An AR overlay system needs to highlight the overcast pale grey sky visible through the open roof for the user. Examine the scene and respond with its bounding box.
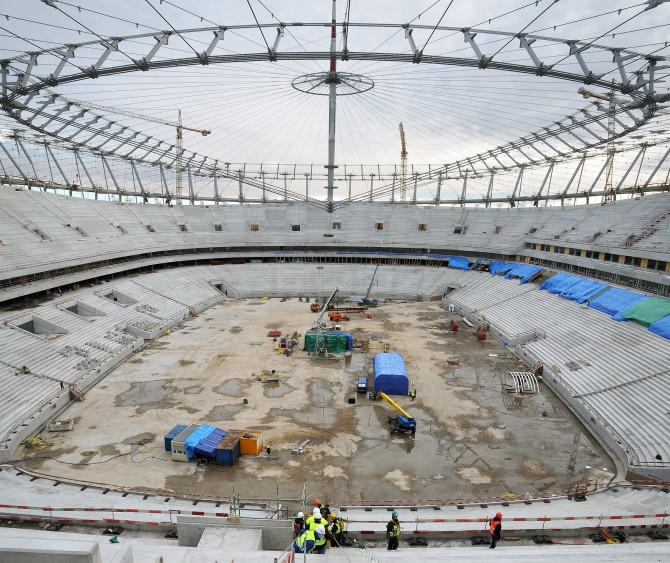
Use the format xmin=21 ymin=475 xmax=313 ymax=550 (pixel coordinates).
xmin=0 ymin=0 xmax=670 ymax=203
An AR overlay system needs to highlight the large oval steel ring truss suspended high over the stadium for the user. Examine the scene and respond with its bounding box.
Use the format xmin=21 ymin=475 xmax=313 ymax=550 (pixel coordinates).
xmin=0 ymin=18 xmax=670 ymax=210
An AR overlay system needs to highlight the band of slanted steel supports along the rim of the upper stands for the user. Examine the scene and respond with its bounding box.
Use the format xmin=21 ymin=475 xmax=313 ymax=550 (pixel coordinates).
xmin=0 ymin=132 xmax=670 ymax=209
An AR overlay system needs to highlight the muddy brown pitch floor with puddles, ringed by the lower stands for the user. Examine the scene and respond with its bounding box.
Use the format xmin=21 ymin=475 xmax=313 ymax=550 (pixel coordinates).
xmin=19 ymin=299 xmax=614 ymax=505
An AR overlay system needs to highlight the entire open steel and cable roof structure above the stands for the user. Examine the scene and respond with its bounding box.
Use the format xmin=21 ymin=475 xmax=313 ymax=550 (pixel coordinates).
xmin=0 ymin=0 xmax=670 ymax=211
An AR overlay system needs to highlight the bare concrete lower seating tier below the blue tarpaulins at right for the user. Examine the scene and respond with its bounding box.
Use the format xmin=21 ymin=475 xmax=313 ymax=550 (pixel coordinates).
xmin=447 ymin=272 xmax=670 ymax=472
